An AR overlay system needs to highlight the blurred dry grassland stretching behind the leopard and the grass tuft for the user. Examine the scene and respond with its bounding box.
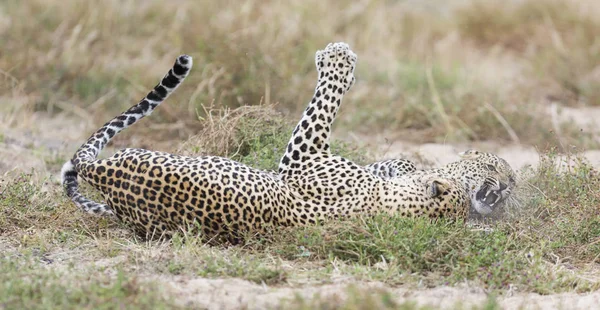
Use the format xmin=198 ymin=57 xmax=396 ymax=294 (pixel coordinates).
xmin=0 ymin=0 xmax=600 ymax=173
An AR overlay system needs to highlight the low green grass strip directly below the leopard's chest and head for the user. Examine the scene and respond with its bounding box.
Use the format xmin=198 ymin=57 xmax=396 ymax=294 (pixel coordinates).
xmin=260 ymin=216 xmax=594 ymax=294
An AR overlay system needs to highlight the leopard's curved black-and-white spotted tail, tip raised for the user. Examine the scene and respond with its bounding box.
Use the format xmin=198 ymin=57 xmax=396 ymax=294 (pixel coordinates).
xmin=61 ymin=55 xmax=192 ymax=214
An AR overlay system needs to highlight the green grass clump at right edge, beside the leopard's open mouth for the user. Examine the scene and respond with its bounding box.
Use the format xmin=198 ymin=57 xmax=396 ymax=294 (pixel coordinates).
xmin=512 ymin=153 xmax=600 ymax=264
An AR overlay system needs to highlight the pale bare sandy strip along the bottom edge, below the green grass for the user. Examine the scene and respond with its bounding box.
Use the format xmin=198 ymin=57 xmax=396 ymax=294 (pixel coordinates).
xmin=142 ymin=276 xmax=600 ymax=309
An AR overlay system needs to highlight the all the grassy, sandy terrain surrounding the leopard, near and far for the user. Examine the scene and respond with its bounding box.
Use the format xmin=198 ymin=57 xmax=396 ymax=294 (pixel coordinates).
xmin=0 ymin=0 xmax=600 ymax=309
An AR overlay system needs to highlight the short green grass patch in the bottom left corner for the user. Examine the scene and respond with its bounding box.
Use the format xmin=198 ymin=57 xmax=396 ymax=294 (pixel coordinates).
xmin=0 ymin=255 xmax=182 ymax=309
